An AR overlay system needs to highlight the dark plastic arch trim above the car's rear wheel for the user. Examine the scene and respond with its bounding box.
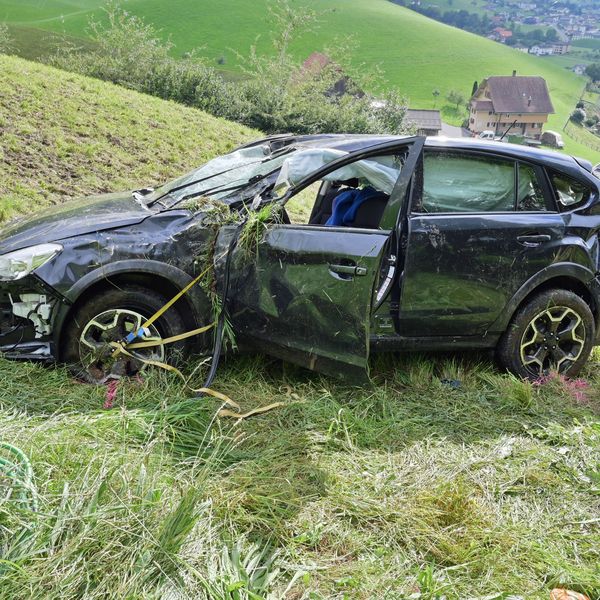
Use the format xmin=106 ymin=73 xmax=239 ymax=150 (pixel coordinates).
xmin=490 ymin=263 xmax=600 ymax=332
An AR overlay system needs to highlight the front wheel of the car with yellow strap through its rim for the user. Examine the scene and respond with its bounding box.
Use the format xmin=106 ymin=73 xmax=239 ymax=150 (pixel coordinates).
xmin=61 ymin=285 xmax=186 ymax=384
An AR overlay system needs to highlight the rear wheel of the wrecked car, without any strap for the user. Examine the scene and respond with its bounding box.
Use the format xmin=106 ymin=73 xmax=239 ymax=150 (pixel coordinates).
xmin=497 ymin=289 xmax=596 ymax=380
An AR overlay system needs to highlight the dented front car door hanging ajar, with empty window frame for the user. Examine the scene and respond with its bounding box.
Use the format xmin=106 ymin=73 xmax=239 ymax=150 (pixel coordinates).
xmin=221 ymin=138 xmax=424 ymax=378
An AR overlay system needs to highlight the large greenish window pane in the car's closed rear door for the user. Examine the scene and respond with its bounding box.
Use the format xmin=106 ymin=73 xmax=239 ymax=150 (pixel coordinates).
xmin=420 ymin=152 xmax=515 ymax=213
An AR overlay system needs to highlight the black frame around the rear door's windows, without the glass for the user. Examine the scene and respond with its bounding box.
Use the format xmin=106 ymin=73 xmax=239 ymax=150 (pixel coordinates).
xmin=410 ymin=148 xmax=559 ymax=217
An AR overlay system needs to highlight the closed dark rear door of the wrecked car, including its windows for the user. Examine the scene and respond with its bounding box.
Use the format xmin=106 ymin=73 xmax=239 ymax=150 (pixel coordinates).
xmin=399 ymin=149 xmax=565 ymax=337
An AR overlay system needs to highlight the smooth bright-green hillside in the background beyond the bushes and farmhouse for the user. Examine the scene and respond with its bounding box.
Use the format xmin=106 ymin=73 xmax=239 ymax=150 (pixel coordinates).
xmin=0 ymin=0 xmax=600 ymax=162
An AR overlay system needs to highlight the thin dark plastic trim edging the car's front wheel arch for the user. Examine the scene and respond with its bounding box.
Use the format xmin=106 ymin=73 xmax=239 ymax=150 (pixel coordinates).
xmin=52 ymin=259 xmax=210 ymax=348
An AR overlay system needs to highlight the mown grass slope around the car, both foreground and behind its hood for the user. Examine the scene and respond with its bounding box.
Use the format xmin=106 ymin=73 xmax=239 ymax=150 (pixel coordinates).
xmin=0 ymin=58 xmax=600 ymax=600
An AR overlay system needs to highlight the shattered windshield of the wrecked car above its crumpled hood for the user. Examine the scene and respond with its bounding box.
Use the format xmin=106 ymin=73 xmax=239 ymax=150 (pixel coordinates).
xmin=148 ymin=144 xmax=295 ymax=206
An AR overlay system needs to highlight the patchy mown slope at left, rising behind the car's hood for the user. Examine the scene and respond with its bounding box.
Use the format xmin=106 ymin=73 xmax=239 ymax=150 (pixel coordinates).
xmin=0 ymin=55 xmax=255 ymax=218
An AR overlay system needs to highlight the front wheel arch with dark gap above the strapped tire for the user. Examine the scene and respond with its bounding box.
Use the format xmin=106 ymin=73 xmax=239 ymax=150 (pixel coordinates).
xmin=53 ymin=260 xmax=210 ymax=354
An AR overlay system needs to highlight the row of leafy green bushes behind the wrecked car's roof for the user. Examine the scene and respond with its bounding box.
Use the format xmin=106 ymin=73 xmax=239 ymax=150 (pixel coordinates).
xmin=49 ymin=0 xmax=409 ymax=134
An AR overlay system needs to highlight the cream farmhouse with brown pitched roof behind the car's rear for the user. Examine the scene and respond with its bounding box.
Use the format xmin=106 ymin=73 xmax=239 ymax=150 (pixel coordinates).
xmin=469 ymin=71 xmax=554 ymax=140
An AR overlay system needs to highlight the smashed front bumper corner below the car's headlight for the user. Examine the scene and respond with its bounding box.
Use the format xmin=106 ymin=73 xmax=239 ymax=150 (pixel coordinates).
xmin=0 ymin=276 xmax=62 ymax=361
